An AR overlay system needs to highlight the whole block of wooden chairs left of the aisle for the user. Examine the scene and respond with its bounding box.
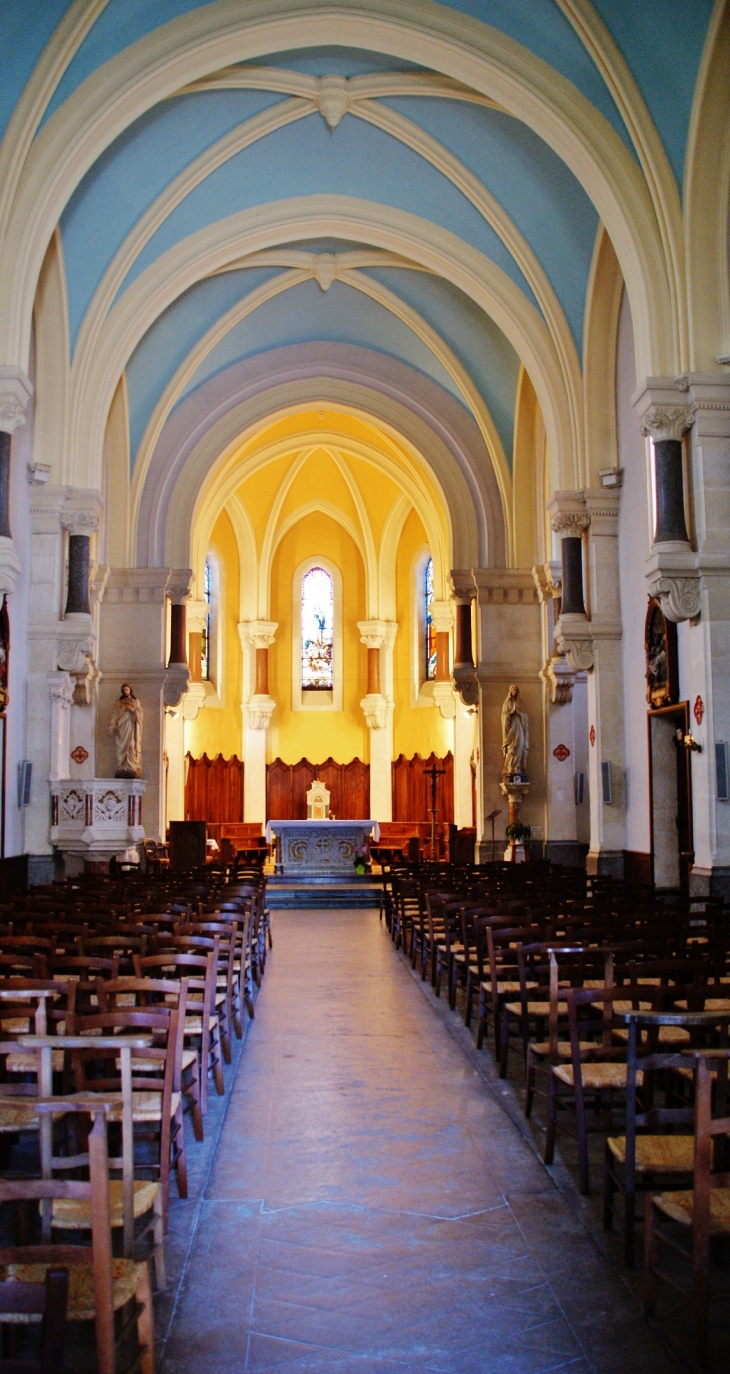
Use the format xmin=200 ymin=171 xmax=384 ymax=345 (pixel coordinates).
xmin=0 ymin=851 xmax=271 ymax=1374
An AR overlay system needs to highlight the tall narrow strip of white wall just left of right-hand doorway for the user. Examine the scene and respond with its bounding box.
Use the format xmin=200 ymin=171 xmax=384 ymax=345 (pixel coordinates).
xmin=616 ymin=291 xmax=650 ymax=853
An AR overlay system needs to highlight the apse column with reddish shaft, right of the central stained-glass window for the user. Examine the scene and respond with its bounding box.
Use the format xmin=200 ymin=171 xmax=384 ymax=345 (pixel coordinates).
xmin=357 ymin=620 xmax=397 ymax=820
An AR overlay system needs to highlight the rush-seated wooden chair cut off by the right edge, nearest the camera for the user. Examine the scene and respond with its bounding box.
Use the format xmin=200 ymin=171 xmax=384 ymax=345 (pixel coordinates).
xmin=643 ymin=1048 xmax=730 ymax=1369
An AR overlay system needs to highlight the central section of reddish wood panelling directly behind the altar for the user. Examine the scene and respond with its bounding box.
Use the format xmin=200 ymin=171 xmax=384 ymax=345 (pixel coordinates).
xmin=267 ymin=758 xmax=370 ymax=820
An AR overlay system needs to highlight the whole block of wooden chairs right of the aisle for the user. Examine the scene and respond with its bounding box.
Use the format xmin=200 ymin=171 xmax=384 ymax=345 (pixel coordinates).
xmin=382 ymin=864 xmax=730 ymax=1364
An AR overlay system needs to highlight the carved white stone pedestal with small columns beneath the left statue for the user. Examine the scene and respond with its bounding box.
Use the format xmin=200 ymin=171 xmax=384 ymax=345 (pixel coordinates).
xmin=49 ymin=778 xmax=147 ymax=864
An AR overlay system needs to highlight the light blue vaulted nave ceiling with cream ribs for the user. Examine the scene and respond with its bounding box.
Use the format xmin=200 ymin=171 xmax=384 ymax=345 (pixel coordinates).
xmin=0 ymin=0 xmax=712 ymax=568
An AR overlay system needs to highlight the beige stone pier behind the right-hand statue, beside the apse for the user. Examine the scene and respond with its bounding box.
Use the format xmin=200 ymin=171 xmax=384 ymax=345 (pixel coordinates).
xmin=473 ymin=567 xmax=546 ymax=861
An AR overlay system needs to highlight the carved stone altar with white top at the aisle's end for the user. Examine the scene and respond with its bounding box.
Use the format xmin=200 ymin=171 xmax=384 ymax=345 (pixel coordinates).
xmin=267 ymin=820 xmax=381 ymax=878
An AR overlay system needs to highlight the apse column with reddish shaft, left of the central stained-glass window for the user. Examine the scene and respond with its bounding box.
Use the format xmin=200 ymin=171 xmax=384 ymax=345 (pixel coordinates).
xmin=238 ymin=620 xmax=279 ymax=826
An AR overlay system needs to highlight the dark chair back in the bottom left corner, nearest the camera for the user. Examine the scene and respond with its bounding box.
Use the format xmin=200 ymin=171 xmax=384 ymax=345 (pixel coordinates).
xmin=0 ymin=1267 xmax=69 ymax=1374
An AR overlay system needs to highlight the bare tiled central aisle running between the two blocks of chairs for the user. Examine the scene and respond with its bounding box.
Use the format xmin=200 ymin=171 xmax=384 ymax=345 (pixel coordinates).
xmin=162 ymin=911 xmax=675 ymax=1374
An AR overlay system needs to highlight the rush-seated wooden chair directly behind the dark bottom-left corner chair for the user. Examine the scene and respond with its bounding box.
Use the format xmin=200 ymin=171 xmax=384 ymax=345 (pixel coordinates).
xmin=0 ymin=1096 xmax=154 ymax=1374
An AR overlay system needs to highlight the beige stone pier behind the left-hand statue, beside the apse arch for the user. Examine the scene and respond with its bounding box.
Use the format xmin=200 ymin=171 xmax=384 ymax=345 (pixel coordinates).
xmin=96 ymin=567 xmax=172 ymax=840
